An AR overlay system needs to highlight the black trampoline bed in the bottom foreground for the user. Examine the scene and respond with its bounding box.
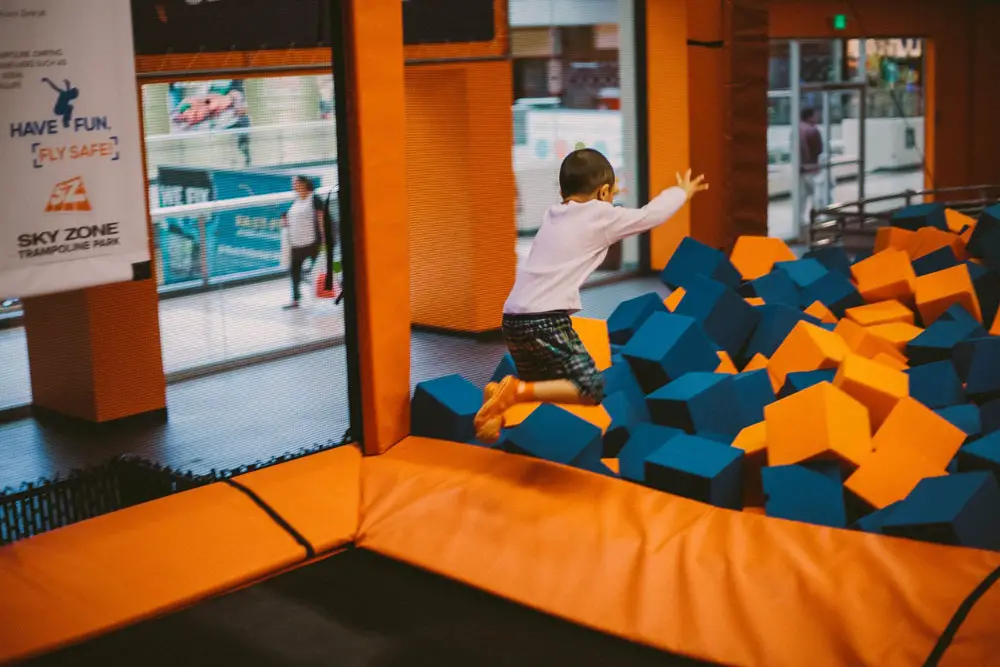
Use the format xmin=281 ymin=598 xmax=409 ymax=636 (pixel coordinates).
xmin=28 ymin=550 xmax=707 ymax=667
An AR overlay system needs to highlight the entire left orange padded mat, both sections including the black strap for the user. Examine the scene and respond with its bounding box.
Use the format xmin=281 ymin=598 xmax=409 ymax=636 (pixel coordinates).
xmin=0 ymin=447 xmax=361 ymax=664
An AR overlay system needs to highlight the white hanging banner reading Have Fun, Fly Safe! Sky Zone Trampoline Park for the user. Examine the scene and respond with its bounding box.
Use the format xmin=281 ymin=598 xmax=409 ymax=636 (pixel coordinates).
xmin=0 ymin=0 xmax=150 ymax=297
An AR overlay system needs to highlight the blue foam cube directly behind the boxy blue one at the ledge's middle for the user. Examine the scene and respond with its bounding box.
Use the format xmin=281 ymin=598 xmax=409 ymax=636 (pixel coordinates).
xmin=646 ymin=373 xmax=740 ymax=436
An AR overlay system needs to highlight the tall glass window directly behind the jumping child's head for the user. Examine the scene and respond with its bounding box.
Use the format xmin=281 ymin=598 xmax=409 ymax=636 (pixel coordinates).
xmin=510 ymin=0 xmax=640 ymax=280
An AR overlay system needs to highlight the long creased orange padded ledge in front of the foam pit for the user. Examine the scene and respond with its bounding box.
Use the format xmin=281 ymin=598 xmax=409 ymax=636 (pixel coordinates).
xmin=358 ymin=438 xmax=1000 ymax=667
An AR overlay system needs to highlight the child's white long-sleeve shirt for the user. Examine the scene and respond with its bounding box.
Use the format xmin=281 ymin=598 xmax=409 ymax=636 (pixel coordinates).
xmin=504 ymin=187 xmax=687 ymax=315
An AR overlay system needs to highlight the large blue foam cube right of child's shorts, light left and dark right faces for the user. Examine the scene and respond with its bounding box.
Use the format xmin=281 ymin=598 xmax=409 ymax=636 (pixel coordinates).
xmin=622 ymin=313 xmax=719 ymax=394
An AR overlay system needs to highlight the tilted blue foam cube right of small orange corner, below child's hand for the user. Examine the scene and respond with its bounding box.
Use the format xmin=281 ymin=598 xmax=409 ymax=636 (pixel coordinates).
xmin=674 ymin=276 xmax=760 ymax=356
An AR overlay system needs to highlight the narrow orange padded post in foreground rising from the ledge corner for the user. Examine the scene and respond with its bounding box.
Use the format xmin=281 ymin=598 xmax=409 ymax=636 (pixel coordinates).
xmin=343 ymin=0 xmax=412 ymax=454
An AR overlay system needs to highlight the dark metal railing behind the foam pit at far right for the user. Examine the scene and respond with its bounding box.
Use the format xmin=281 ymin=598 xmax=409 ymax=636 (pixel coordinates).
xmin=807 ymin=185 xmax=1000 ymax=250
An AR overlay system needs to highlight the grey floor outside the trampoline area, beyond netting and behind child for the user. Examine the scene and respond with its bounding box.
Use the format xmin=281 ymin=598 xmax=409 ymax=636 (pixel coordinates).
xmin=0 ymin=277 xmax=667 ymax=490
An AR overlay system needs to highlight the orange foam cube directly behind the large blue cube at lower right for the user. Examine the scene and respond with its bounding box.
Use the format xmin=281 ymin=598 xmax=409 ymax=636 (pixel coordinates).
xmin=844 ymin=451 xmax=944 ymax=509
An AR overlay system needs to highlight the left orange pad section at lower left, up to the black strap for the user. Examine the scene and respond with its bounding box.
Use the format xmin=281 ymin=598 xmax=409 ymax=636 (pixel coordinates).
xmin=0 ymin=484 xmax=305 ymax=663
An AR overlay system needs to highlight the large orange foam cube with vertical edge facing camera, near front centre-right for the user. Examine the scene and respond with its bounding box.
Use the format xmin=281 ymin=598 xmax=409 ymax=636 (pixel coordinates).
xmin=764 ymin=382 xmax=872 ymax=469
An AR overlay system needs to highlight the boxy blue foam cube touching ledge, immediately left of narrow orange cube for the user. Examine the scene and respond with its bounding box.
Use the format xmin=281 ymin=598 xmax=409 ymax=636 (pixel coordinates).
xmin=646 ymin=435 xmax=743 ymax=509
